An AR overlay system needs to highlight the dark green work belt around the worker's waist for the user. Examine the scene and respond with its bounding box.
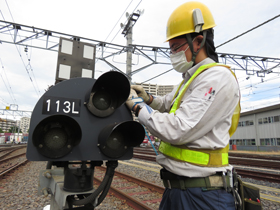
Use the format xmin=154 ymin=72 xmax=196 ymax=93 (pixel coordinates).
xmin=161 ymin=169 xmax=230 ymax=190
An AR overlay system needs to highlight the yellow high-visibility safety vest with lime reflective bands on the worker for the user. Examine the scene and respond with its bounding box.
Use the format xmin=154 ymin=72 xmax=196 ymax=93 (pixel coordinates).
xmin=159 ymin=63 xmax=241 ymax=167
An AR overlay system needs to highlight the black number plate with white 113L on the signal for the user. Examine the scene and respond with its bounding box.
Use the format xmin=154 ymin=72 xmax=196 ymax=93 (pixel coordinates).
xmin=43 ymin=96 xmax=81 ymax=116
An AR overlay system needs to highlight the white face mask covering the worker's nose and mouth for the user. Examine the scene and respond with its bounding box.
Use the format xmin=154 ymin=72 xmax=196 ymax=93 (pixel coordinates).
xmin=170 ymin=38 xmax=195 ymax=73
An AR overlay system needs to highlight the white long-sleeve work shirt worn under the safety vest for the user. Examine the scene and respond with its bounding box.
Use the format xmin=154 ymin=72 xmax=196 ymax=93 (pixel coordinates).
xmin=138 ymin=58 xmax=239 ymax=177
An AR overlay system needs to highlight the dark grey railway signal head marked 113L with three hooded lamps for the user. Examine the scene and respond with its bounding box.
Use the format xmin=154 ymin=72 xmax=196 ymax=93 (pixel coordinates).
xmin=27 ymin=71 xmax=145 ymax=161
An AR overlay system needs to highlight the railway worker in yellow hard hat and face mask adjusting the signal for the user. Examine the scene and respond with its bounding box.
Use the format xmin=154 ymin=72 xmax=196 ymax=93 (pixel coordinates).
xmin=126 ymin=2 xmax=240 ymax=210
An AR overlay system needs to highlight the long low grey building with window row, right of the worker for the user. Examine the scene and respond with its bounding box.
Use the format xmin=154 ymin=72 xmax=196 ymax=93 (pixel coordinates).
xmin=230 ymin=104 xmax=280 ymax=151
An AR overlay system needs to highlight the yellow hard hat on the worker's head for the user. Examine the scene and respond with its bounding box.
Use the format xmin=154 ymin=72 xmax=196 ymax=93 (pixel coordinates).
xmin=166 ymin=1 xmax=216 ymax=41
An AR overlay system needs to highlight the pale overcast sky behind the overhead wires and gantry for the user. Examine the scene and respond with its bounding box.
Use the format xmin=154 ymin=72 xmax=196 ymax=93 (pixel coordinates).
xmin=0 ymin=0 xmax=280 ymax=120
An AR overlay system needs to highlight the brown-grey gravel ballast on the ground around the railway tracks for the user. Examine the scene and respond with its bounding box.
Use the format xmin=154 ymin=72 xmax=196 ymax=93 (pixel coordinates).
xmin=0 ymin=160 xmax=280 ymax=210
